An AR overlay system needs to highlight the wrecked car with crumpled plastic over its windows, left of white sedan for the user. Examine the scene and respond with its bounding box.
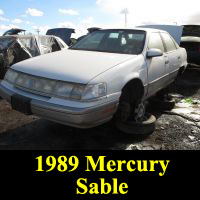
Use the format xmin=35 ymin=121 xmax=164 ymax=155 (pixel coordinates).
xmin=0 ymin=35 xmax=68 ymax=79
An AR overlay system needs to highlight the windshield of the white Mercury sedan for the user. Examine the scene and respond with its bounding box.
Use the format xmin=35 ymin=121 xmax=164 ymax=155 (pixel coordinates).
xmin=70 ymin=30 xmax=146 ymax=55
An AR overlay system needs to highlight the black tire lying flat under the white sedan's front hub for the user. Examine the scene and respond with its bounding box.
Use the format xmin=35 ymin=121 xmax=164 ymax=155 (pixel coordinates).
xmin=115 ymin=114 xmax=156 ymax=135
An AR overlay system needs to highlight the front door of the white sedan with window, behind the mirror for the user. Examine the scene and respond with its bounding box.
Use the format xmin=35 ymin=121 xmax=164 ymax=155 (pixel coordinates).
xmin=147 ymin=32 xmax=169 ymax=96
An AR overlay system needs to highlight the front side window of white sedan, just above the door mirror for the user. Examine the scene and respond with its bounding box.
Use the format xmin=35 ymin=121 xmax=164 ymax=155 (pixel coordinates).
xmin=148 ymin=33 xmax=164 ymax=52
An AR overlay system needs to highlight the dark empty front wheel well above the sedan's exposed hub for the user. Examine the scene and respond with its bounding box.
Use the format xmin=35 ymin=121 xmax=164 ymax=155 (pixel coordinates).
xmin=122 ymin=79 xmax=144 ymax=100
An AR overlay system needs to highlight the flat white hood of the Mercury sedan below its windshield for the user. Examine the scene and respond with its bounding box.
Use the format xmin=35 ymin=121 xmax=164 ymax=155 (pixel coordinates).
xmin=12 ymin=49 xmax=136 ymax=84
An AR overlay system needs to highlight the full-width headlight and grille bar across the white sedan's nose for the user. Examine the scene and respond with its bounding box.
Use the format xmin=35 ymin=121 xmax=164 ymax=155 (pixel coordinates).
xmin=5 ymin=69 xmax=107 ymax=100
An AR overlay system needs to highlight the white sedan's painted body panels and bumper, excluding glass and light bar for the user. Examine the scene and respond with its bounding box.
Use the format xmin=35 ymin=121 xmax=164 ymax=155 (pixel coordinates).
xmin=0 ymin=28 xmax=187 ymax=128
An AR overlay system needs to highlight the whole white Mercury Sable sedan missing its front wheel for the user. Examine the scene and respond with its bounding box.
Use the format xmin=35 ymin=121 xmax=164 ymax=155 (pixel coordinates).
xmin=0 ymin=28 xmax=187 ymax=132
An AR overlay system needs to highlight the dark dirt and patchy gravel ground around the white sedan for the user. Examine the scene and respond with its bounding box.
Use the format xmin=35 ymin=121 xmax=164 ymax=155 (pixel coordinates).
xmin=0 ymin=68 xmax=200 ymax=150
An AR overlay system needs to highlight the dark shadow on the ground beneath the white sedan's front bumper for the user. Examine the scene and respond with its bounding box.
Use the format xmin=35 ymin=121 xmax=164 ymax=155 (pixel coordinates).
xmin=0 ymin=119 xmax=150 ymax=150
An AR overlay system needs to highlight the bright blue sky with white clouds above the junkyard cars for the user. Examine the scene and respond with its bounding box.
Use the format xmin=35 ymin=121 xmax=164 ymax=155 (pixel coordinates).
xmin=0 ymin=0 xmax=200 ymax=38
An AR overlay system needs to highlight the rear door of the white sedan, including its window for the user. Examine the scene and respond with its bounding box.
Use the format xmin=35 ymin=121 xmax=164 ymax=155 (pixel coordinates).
xmin=161 ymin=32 xmax=182 ymax=82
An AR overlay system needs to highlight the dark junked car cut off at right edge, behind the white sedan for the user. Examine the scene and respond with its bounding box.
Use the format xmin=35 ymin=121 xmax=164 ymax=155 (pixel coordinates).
xmin=180 ymin=25 xmax=200 ymax=65
